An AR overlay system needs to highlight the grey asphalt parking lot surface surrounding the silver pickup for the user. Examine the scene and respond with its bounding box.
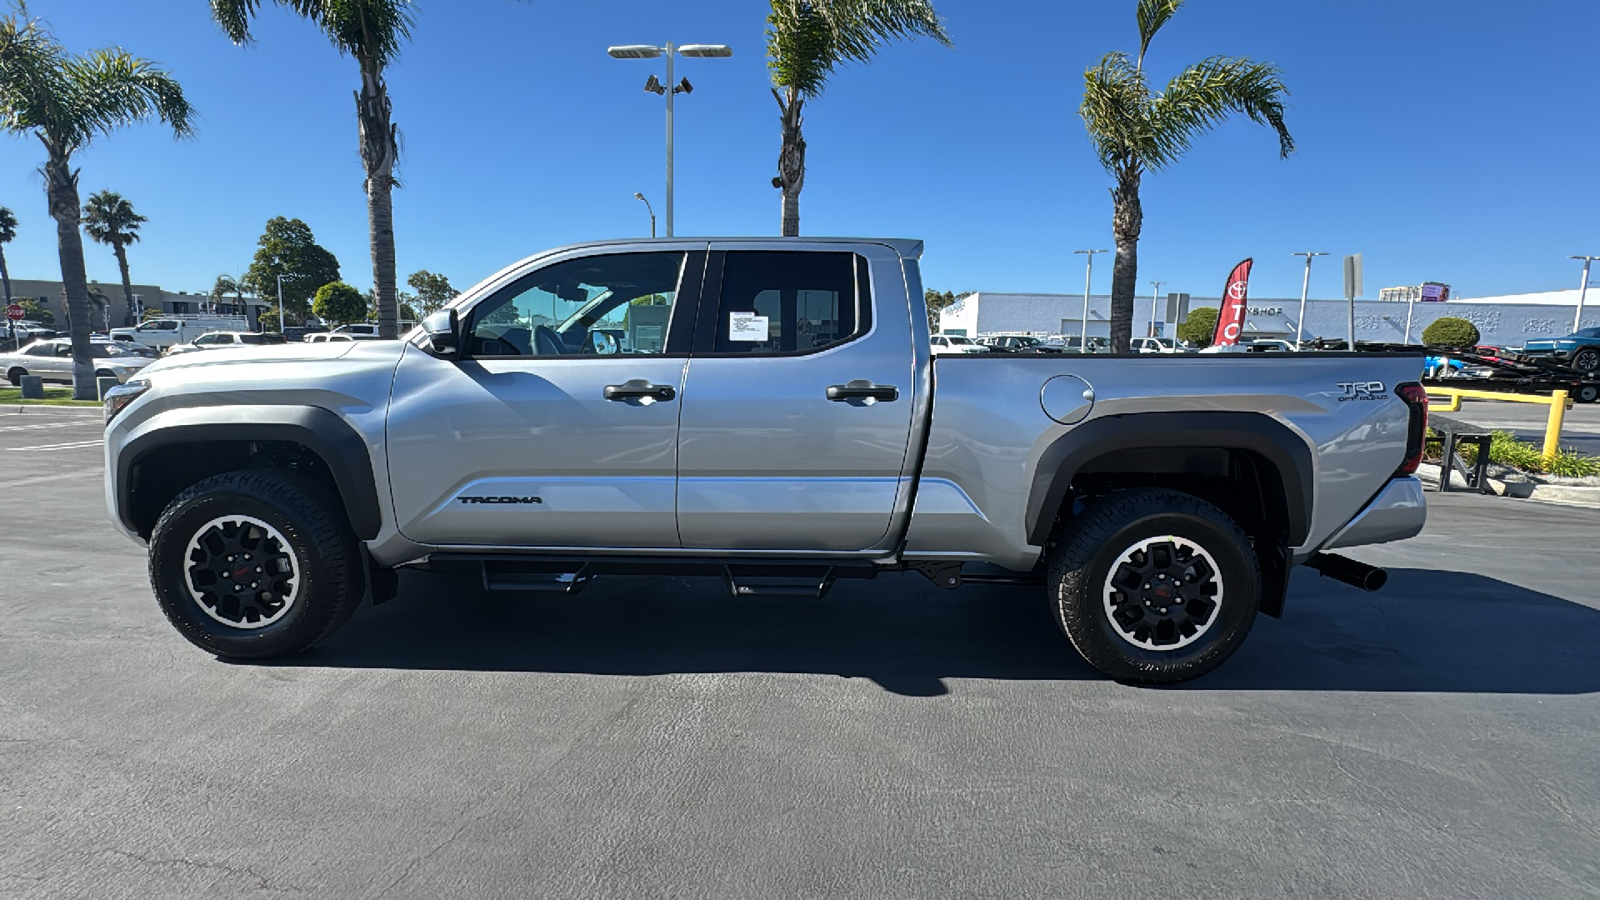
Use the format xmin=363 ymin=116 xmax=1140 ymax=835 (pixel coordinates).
xmin=0 ymin=410 xmax=1600 ymax=898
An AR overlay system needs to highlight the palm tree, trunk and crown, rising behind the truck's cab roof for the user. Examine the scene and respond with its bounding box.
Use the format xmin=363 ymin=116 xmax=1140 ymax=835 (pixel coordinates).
xmin=766 ymin=0 xmax=950 ymax=237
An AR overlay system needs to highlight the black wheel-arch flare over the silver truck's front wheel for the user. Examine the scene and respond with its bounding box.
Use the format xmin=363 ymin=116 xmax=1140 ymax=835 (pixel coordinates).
xmin=115 ymin=407 xmax=382 ymax=540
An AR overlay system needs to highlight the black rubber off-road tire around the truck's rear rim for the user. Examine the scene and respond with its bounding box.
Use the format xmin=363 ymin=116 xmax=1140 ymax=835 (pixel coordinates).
xmin=1045 ymin=488 xmax=1261 ymax=684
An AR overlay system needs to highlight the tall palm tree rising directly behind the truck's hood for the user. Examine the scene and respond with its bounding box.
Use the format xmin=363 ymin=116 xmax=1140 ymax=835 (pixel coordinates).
xmin=211 ymin=0 xmax=414 ymax=338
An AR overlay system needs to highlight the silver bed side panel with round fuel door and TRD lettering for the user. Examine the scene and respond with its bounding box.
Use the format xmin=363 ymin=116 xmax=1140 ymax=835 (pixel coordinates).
xmin=906 ymin=354 xmax=1422 ymax=570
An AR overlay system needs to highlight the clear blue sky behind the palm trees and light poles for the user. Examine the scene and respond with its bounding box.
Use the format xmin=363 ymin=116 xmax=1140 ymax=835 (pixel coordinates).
xmin=0 ymin=0 xmax=1600 ymax=298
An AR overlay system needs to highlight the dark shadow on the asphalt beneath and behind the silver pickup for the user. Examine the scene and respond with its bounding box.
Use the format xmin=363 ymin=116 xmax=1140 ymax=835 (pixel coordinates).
xmin=286 ymin=569 xmax=1600 ymax=697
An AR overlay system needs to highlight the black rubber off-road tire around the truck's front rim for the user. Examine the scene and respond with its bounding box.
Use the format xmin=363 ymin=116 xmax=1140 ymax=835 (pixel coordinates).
xmin=150 ymin=469 xmax=365 ymax=660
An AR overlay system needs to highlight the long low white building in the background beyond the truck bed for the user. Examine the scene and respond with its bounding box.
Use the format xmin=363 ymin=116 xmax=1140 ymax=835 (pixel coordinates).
xmin=939 ymin=288 xmax=1600 ymax=346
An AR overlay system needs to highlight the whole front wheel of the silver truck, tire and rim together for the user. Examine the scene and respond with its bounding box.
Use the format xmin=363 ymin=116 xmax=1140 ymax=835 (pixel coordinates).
xmin=150 ymin=469 xmax=363 ymax=660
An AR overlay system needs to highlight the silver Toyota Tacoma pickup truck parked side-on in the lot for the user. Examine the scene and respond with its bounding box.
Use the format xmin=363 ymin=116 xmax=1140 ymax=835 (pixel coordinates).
xmin=106 ymin=239 xmax=1427 ymax=682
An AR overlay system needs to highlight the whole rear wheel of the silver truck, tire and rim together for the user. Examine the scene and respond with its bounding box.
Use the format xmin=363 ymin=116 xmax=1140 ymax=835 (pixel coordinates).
xmin=1046 ymin=488 xmax=1261 ymax=684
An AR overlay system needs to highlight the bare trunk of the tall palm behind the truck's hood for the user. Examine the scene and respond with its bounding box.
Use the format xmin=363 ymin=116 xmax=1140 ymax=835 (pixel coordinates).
xmin=355 ymin=59 xmax=400 ymax=338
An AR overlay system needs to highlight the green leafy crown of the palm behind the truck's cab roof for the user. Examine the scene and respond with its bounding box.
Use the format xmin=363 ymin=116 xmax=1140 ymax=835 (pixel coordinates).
xmin=766 ymin=0 xmax=950 ymax=96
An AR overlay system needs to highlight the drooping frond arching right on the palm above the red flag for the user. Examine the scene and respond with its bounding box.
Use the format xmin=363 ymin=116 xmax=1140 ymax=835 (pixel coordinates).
xmin=1142 ymin=56 xmax=1294 ymax=170
